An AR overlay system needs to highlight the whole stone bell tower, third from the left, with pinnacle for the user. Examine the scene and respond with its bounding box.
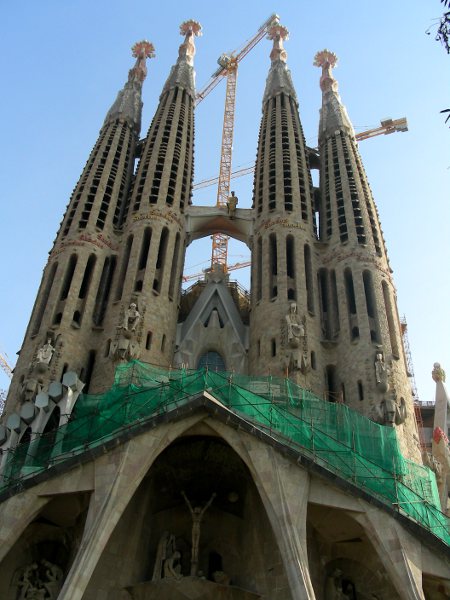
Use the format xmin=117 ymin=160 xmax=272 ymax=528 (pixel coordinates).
xmin=249 ymin=23 xmax=320 ymax=392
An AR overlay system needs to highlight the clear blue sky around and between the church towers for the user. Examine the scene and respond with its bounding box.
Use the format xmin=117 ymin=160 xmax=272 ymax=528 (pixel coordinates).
xmin=0 ymin=0 xmax=450 ymax=400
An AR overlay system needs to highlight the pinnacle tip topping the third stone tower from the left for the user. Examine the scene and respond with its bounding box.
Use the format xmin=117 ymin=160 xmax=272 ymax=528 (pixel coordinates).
xmin=263 ymin=21 xmax=298 ymax=106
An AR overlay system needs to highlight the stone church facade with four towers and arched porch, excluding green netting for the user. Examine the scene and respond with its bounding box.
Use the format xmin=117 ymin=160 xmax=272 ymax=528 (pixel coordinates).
xmin=0 ymin=21 xmax=450 ymax=600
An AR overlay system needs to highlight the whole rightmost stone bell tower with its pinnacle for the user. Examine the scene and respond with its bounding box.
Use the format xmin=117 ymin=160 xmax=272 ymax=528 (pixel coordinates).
xmin=314 ymin=50 xmax=420 ymax=459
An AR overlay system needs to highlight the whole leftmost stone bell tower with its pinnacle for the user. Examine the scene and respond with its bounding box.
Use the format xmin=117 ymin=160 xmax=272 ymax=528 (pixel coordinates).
xmin=8 ymin=41 xmax=154 ymax=408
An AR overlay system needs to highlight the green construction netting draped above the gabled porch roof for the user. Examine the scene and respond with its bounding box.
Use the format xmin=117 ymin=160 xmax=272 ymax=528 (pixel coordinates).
xmin=0 ymin=361 xmax=450 ymax=545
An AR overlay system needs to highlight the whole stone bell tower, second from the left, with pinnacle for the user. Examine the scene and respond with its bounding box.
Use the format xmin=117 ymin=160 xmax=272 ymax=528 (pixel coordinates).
xmin=98 ymin=20 xmax=201 ymax=385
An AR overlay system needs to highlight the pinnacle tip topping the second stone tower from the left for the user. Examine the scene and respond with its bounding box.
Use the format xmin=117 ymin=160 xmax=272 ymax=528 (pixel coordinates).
xmin=162 ymin=19 xmax=202 ymax=96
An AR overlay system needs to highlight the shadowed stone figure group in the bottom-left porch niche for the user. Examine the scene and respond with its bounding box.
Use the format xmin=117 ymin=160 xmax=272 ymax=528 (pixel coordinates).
xmin=17 ymin=558 xmax=63 ymax=600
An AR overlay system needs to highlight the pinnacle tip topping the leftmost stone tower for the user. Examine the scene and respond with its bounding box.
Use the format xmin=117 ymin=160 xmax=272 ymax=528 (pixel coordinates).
xmin=104 ymin=40 xmax=155 ymax=132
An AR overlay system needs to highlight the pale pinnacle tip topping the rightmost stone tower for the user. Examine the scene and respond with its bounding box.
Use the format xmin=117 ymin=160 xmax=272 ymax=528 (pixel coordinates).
xmin=313 ymin=49 xmax=355 ymax=140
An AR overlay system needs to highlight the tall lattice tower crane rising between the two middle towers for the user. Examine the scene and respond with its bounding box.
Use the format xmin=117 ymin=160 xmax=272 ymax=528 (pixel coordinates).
xmin=196 ymin=14 xmax=279 ymax=271
